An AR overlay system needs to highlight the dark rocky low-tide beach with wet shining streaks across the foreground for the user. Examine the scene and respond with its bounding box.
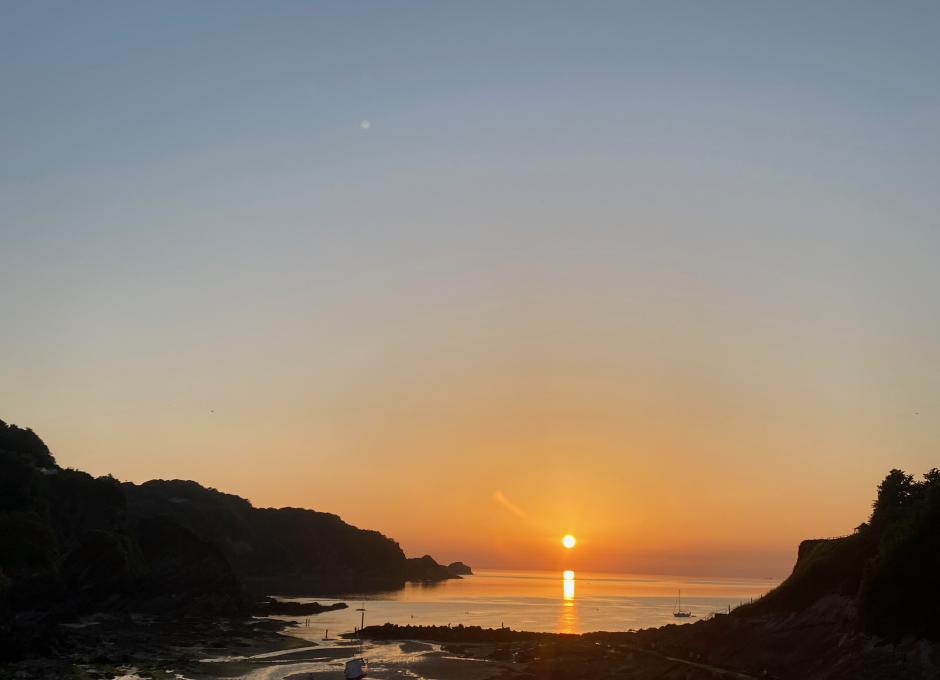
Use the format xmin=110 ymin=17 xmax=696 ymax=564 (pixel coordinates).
xmin=0 ymin=596 xmax=940 ymax=680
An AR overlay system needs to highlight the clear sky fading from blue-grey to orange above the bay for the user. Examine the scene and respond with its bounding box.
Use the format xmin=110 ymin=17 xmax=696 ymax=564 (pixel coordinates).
xmin=0 ymin=1 xmax=940 ymax=576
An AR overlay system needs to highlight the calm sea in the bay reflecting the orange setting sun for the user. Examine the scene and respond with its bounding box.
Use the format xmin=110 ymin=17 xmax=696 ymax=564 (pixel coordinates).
xmin=280 ymin=570 xmax=778 ymax=640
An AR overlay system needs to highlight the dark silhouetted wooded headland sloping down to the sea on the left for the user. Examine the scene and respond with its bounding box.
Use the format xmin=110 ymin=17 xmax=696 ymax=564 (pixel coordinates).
xmin=0 ymin=414 xmax=462 ymax=656
